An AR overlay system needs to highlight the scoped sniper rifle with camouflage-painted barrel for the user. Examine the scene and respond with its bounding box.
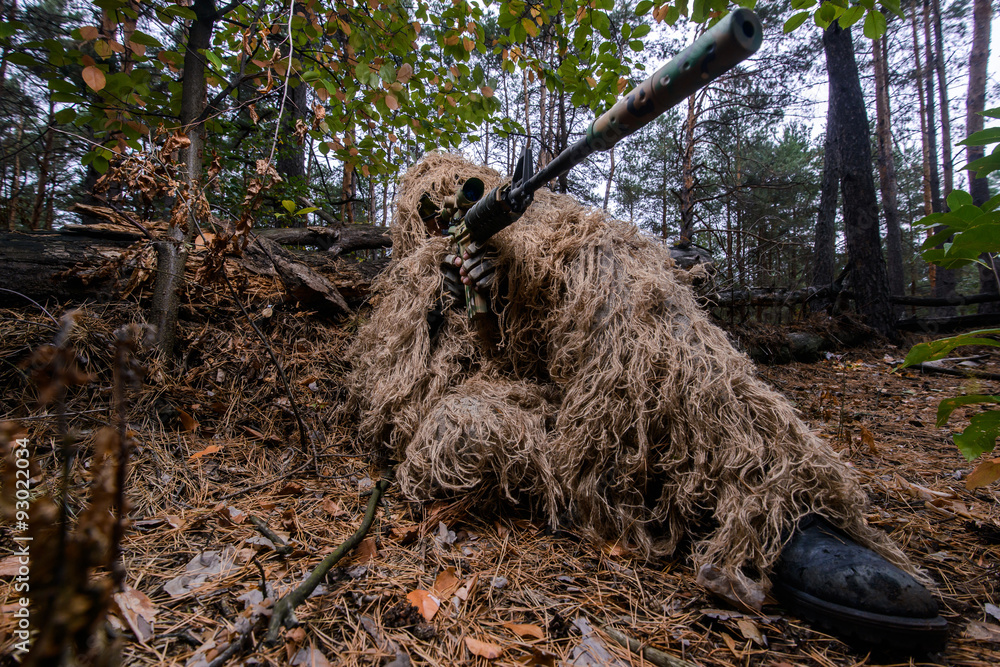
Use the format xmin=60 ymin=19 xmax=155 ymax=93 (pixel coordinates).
xmin=420 ymin=9 xmax=763 ymax=319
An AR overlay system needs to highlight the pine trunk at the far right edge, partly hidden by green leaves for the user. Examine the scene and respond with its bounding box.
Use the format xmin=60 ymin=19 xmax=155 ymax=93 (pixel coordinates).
xmin=965 ymin=0 xmax=1000 ymax=313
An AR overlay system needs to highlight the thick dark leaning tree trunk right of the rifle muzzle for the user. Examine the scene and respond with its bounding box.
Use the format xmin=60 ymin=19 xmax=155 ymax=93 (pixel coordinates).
xmin=823 ymin=21 xmax=895 ymax=337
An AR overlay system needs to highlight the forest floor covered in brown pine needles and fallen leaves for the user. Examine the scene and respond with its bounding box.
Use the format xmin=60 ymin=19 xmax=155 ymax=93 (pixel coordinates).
xmin=0 ymin=298 xmax=1000 ymax=667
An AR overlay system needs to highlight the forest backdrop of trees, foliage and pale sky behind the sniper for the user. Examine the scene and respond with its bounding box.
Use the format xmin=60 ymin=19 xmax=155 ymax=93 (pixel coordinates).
xmin=0 ymin=0 xmax=1000 ymax=326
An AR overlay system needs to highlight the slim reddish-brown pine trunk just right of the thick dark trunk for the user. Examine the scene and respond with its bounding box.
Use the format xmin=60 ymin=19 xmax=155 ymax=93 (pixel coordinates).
xmin=876 ymin=36 xmax=904 ymax=295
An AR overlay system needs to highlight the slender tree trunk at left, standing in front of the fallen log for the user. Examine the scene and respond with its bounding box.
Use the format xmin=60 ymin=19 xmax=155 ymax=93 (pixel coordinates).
xmin=151 ymin=0 xmax=217 ymax=358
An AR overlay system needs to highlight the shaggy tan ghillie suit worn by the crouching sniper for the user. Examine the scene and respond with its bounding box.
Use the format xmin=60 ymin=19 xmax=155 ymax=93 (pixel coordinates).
xmin=351 ymin=155 xmax=912 ymax=584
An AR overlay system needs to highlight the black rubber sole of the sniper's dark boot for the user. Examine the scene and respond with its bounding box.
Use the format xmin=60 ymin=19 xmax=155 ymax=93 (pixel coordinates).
xmin=773 ymin=583 xmax=948 ymax=654
